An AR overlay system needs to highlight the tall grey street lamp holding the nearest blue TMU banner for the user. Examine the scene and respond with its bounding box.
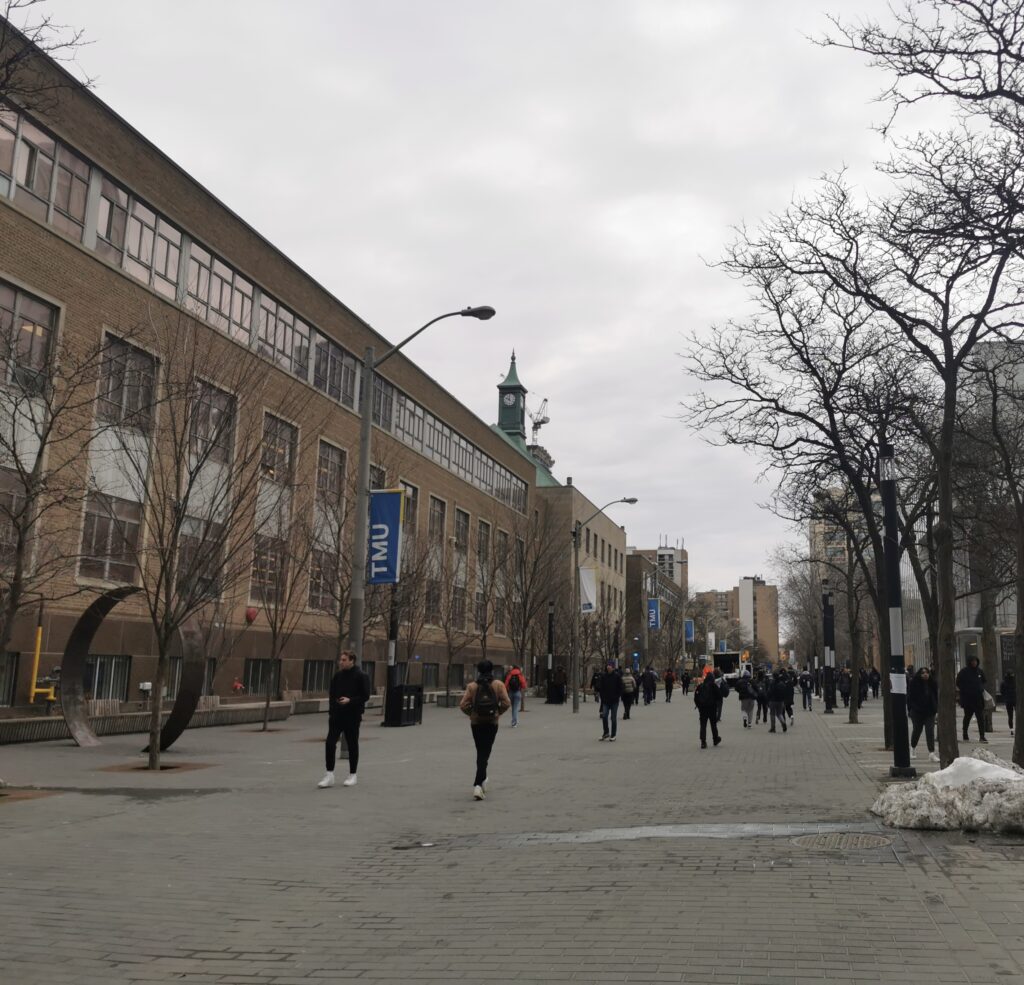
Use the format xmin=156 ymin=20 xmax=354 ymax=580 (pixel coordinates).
xmin=348 ymin=305 xmax=495 ymax=667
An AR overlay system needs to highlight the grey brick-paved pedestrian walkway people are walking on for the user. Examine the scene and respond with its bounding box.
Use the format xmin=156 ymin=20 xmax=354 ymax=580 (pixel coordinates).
xmin=0 ymin=694 xmax=1024 ymax=985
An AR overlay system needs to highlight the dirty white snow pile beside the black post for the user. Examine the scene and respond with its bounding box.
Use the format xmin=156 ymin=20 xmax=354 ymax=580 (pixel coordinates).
xmin=871 ymin=750 xmax=1024 ymax=831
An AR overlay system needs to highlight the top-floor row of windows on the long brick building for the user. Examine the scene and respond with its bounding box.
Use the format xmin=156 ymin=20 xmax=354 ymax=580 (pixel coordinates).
xmin=0 ymin=106 xmax=527 ymax=513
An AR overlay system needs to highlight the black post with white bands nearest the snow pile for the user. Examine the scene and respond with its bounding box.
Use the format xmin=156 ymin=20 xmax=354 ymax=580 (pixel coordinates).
xmin=879 ymin=436 xmax=918 ymax=776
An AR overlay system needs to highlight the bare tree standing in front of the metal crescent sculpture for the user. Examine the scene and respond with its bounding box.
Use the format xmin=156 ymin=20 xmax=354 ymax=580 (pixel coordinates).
xmin=97 ymin=309 xmax=309 ymax=769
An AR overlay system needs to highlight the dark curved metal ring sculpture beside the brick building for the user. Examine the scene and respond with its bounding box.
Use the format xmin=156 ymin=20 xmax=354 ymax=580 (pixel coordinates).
xmin=60 ymin=586 xmax=206 ymax=752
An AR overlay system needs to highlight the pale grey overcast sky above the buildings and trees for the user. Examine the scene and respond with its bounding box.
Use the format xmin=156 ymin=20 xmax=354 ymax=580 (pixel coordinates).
xmin=50 ymin=0 xmax=897 ymax=589
